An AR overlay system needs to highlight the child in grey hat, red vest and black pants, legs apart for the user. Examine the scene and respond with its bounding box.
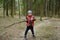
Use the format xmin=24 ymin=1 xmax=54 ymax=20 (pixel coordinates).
xmin=25 ymin=10 xmax=35 ymax=38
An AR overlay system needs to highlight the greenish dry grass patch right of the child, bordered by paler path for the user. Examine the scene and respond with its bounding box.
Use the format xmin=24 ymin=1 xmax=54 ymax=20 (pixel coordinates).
xmin=37 ymin=26 xmax=57 ymax=40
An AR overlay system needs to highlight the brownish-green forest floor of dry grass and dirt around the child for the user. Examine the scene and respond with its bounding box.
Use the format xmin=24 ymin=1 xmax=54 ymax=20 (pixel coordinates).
xmin=0 ymin=17 xmax=60 ymax=40
